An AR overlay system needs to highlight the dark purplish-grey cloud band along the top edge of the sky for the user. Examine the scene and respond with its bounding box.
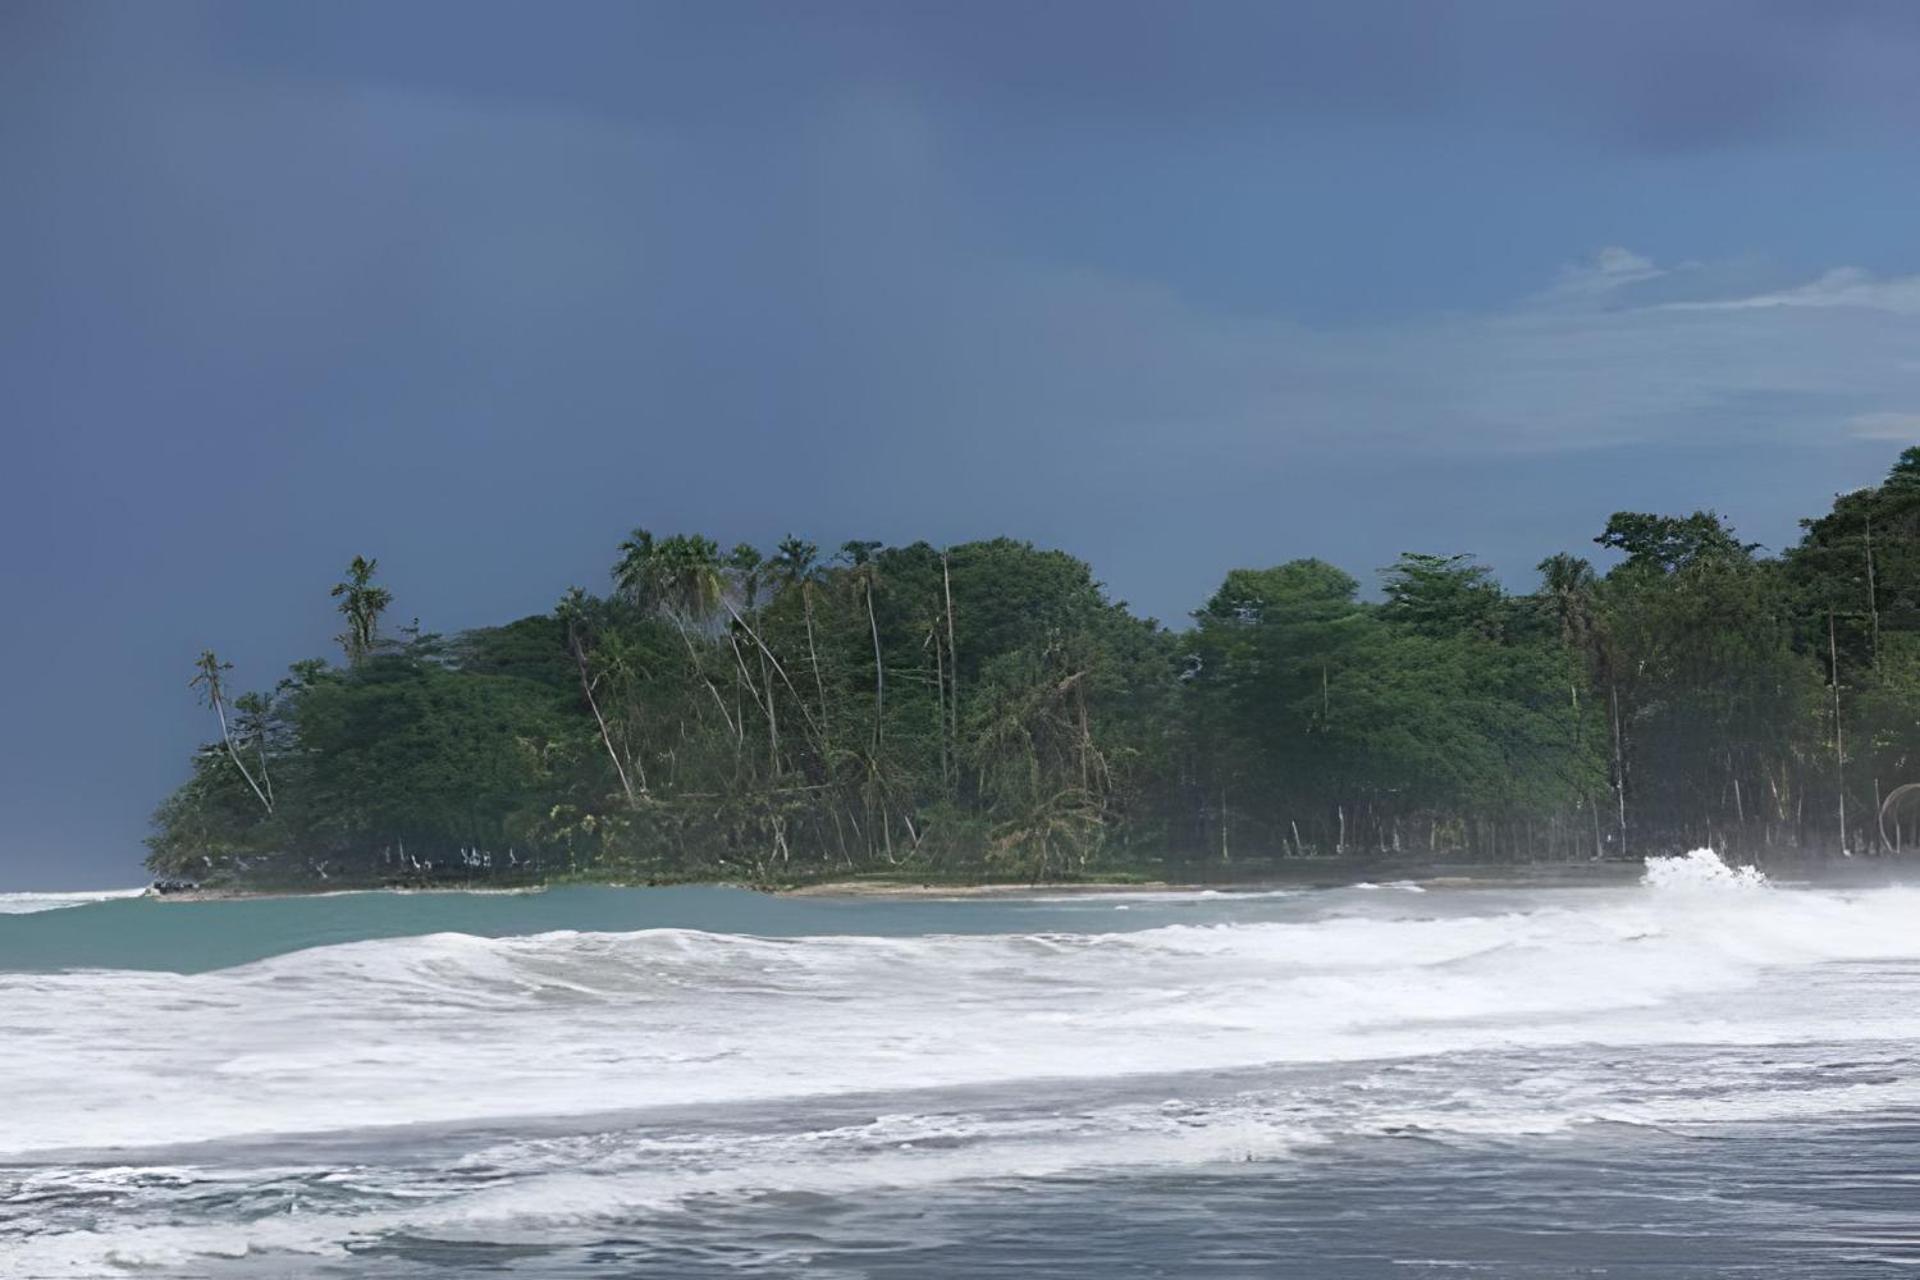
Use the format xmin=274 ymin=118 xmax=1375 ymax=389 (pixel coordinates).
xmin=194 ymin=0 xmax=1920 ymax=148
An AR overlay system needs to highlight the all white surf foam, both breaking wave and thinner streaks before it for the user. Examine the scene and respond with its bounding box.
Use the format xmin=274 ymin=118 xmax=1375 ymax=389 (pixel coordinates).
xmin=0 ymin=852 xmax=1920 ymax=1274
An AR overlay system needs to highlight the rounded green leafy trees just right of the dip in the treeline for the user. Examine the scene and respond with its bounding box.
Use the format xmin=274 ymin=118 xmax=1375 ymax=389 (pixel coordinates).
xmin=1190 ymin=555 xmax=1599 ymax=856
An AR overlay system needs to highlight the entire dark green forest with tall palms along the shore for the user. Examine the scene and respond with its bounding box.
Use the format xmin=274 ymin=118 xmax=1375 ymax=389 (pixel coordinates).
xmin=148 ymin=447 xmax=1920 ymax=885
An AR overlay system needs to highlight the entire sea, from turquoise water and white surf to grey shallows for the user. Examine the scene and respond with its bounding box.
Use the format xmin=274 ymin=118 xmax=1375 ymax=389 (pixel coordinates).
xmin=0 ymin=850 xmax=1920 ymax=1276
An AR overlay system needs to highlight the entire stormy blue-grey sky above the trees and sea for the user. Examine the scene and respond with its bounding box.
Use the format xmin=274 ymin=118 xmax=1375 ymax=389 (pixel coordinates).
xmin=0 ymin=0 xmax=1920 ymax=890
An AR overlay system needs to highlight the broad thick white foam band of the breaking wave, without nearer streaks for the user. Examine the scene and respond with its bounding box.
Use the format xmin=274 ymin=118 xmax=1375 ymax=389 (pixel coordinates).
xmin=0 ymin=858 xmax=1920 ymax=1151
